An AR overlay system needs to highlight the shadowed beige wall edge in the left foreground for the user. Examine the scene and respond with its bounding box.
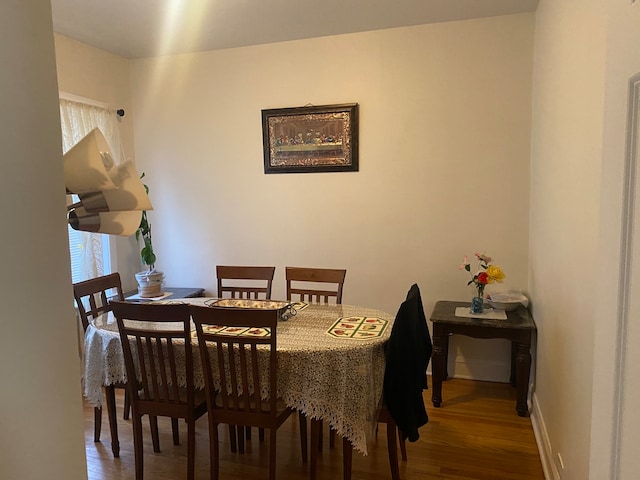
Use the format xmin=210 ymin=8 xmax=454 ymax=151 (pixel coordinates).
xmin=0 ymin=0 xmax=87 ymax=480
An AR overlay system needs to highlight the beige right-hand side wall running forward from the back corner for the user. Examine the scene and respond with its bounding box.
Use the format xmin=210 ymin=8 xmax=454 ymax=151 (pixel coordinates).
xmin=530 ymin=1 xmax=605 ymax=479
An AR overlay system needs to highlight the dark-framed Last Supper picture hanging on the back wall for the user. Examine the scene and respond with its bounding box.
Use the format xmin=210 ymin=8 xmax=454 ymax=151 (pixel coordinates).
xmin=262 ymin=103 xmax=358 ymax=173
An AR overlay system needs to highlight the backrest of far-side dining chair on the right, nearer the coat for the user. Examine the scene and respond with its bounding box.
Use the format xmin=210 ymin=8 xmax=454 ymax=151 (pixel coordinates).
xmin=285 ymin=267 xmax=347 ymax=304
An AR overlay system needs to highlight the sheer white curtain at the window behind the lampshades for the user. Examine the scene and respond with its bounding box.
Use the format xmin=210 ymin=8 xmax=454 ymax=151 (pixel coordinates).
xmin=60 ymin=95 xmax=123 ymax=283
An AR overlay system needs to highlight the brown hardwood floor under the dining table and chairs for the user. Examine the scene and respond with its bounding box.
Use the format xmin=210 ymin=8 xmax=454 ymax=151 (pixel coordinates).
xmin=84 ymin=379 xmax=544 ymax=480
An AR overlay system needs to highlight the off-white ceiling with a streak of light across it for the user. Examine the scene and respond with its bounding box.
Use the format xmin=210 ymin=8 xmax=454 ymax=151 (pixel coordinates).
xmin=51 ymin=0 xmax=538 ymax=58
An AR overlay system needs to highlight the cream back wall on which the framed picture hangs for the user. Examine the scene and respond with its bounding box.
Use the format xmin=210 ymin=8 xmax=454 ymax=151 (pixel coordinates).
xmin=131 ymin=14 xmax=533 ymax=380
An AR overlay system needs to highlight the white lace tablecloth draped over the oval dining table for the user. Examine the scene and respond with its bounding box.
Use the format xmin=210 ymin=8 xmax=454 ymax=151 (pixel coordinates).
xmin=83 ymin=298 xmax=394 ymax=455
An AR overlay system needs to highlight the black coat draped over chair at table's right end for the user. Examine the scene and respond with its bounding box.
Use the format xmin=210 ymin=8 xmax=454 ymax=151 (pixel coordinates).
xmin=383 ymin=284 xmax=433 ymax=442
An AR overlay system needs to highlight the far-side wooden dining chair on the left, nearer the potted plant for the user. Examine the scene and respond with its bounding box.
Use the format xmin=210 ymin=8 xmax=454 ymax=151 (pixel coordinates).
xmin=216 ymin=265 xmax=276 ymax=453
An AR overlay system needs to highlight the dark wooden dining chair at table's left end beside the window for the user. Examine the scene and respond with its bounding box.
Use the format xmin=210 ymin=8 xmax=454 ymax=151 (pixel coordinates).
xmin=73 ymin=272 xmax=130 ymax=457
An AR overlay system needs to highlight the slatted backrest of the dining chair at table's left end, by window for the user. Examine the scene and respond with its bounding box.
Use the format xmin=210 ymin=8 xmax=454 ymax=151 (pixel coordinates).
xmin=73 ymin=272 xmax=124 ymax=330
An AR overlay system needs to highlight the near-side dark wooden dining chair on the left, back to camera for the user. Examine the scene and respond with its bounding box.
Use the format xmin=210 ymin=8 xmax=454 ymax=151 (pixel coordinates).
xmin=111 ymin=301 xmax=207 ymax=480
